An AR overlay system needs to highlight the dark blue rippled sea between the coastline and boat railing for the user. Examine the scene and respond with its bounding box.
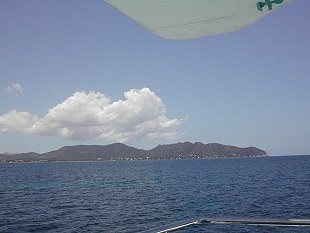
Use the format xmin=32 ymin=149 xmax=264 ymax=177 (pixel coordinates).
xmin=0 ymin=156 xmax=310 ymax=233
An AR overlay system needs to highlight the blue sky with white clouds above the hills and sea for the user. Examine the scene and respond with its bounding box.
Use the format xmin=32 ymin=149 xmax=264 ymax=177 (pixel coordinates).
xmin=0 ymin=0 xmax=310 ymax=155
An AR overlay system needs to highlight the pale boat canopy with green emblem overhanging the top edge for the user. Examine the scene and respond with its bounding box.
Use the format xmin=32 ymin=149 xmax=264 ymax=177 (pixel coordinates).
xmin=106 ymin=0 xmax=290 ymax=40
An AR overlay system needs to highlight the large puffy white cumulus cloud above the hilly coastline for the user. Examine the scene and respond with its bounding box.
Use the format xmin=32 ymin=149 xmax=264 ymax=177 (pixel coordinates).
xmin=0 ymin=88 xmax=185 ymax=142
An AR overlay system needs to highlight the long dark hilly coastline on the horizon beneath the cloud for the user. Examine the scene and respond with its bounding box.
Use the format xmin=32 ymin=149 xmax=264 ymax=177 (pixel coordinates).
xmin=0 ymin=142 xmax=267 ymax=162
